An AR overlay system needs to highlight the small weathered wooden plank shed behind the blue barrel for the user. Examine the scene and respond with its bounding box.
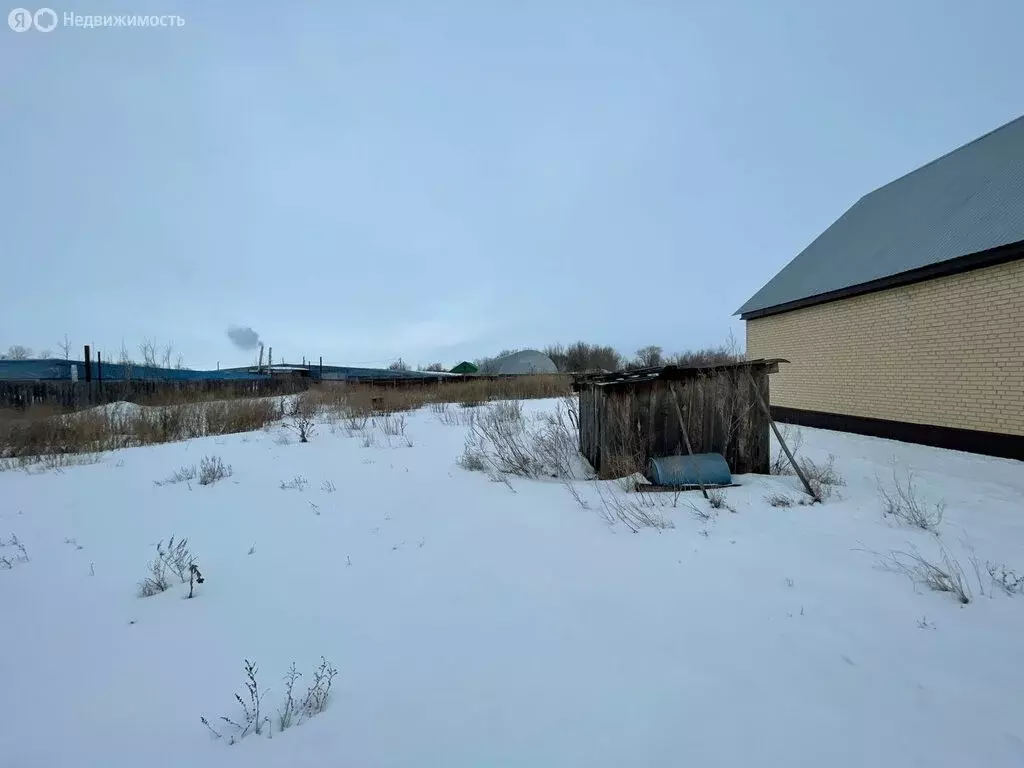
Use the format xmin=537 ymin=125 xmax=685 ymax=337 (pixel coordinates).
xmin=573 ymin=358 xmax=788 ymax=478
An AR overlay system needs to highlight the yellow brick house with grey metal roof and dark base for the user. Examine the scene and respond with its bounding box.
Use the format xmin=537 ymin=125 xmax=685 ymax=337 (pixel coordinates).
xmin=737 ymin=117 xmax=1024 ymax=460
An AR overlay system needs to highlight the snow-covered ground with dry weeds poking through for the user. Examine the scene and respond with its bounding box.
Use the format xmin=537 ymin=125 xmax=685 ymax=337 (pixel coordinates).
xmin=0 ymin=401 xmax=1024 ymax=768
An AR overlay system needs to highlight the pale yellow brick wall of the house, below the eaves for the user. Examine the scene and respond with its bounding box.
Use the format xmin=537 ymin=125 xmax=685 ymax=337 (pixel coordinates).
xmin=746 ymin=260 xmax=1024 ymax=435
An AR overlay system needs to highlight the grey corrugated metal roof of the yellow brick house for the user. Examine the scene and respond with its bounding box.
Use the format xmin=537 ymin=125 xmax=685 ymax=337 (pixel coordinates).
xmin=736 ymin=117 xmax=1024 ymax=314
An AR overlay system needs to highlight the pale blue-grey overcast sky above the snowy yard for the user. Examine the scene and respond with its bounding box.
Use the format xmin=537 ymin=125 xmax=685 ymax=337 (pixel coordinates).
xmin=0 ymin=0 xmax=1024 ymax=368
